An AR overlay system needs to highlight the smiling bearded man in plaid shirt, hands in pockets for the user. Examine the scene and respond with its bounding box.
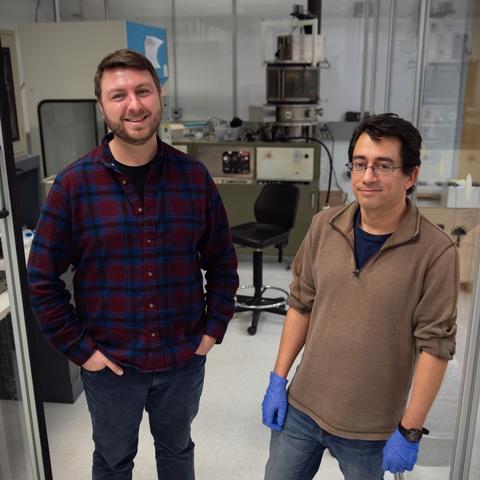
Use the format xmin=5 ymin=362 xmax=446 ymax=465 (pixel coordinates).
xmin=28 ymin=49 xmax=238 ymax=480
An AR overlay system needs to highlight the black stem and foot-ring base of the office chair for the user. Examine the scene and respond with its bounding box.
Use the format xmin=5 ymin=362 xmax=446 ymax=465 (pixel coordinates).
xmin=235 ymin=250 xmax=288 ymax=335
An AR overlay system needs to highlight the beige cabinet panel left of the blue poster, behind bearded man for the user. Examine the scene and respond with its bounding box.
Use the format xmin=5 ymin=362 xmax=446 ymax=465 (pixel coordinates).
xmin=19 ymin=21 xmax=126 ymax=161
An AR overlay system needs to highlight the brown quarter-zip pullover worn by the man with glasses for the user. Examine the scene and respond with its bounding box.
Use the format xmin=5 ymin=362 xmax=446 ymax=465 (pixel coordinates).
xmin=288 ymin=202 xmax=458 ymax=440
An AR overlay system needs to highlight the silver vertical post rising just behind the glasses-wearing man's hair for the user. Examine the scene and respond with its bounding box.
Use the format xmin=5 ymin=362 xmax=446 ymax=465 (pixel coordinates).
xmin=412 ymin=0 xmax=430 ymax=129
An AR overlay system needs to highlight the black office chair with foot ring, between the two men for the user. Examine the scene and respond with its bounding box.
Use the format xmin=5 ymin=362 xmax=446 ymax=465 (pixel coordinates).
xmin=230 ymin=183 xmax=299 ymax=335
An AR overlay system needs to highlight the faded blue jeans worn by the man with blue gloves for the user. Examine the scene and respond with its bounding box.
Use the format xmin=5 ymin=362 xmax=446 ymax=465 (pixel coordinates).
xmin=265 ymin=404 xmax=385 ymax=480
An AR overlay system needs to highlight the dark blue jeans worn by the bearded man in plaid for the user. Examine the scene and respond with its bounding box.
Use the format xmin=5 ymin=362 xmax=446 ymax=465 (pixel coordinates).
xmin=81 ymin=355 xmax=206 ymax=480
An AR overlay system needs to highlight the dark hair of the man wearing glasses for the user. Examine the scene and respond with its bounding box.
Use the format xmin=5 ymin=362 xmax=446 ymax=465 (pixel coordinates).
xmin=348 ymin=113 xmax=422 ymax=195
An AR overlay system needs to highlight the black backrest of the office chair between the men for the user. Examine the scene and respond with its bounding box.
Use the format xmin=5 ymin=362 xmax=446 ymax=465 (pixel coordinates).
xmin=255 ymin=183 xmax=299 ymax=230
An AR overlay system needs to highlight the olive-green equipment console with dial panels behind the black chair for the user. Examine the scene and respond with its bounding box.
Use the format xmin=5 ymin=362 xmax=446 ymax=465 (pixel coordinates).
xmin=174 ymin=140 xmax=320 ymax=256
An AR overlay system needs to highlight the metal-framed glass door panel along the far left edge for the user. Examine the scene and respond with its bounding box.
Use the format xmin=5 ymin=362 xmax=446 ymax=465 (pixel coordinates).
xmin=0 ymin=45 xmax=50 ymax=480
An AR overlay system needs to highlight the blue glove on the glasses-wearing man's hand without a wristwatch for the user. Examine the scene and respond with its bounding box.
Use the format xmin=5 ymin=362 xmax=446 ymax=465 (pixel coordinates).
xmin=262 ymin=372 xmax=288 ymax=431
